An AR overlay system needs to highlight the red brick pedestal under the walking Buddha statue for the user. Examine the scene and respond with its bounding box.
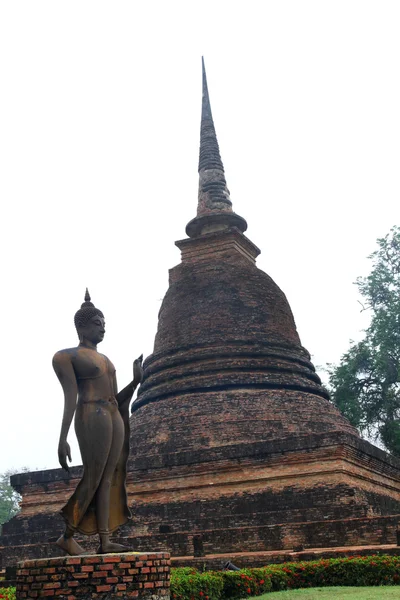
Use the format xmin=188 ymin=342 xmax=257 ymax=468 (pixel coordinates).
xmin=17 ymin=552 xmax=171 ymax=600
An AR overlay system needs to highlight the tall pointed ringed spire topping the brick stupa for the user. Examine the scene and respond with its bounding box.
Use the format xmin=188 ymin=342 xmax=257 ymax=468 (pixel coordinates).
xmin=186 ymin=57 xmax=247 ymax=237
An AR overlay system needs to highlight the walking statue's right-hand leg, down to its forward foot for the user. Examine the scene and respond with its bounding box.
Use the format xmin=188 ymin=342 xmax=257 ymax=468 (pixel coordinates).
xmin=96 ymin=406 xmax=127 ymax=554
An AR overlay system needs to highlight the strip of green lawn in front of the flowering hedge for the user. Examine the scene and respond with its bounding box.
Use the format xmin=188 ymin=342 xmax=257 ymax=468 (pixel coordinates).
xmin=248 ymin=586 xmax=400 ymax=600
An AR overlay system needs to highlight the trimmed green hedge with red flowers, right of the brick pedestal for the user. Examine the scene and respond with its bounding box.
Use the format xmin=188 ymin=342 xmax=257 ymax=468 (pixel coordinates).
xmin=171 ymin=555 xmax=400 ymax=600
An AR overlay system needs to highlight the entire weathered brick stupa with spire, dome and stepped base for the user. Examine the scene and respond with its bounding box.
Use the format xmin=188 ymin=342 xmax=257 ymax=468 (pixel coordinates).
xmin=0 ymin=61 xmax=400 ymax=564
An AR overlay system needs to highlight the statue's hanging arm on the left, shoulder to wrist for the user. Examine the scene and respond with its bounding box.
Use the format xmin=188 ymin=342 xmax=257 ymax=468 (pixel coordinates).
xmin=53 ymin=350 xmax=78 ymax=442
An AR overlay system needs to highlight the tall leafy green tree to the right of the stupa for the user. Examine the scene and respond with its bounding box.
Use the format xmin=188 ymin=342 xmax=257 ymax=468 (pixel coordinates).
xmin=328 ymin=226 xmax=400 ymax=456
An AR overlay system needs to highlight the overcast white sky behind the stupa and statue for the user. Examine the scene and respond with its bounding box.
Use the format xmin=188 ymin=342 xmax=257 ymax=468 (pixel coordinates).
xmin=0 ymin=0 xmax=400 ymax=472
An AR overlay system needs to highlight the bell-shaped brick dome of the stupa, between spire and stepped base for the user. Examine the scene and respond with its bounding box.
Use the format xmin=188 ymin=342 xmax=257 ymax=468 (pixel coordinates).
xmin=133 ymin=229 xmax=355 ymax=454
